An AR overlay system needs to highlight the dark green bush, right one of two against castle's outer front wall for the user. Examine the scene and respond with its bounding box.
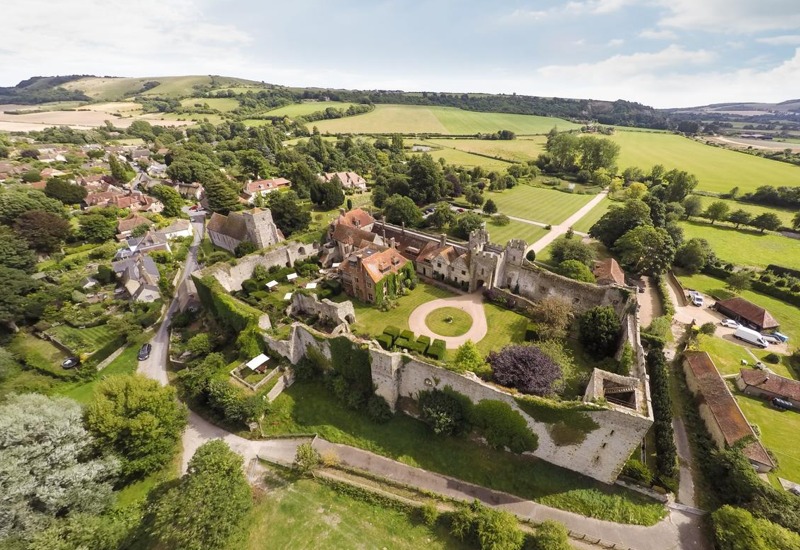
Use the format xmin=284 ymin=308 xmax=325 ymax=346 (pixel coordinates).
xmin=471 ymin=399 xmax=539 ymax=454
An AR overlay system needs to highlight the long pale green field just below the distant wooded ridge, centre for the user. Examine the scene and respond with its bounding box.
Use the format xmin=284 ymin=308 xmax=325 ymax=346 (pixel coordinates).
xmin=308 ymin=105 xmax=578 ymax=135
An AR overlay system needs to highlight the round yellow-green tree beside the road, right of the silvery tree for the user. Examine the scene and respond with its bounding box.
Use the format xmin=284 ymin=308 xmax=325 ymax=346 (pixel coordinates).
xmin=86 ymin=376 xmax=186 ymax=478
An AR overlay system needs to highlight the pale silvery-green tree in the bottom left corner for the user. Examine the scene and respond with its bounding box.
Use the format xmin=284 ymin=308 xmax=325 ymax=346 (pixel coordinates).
xmin=0 ymin=394 xmax=117 ymax=544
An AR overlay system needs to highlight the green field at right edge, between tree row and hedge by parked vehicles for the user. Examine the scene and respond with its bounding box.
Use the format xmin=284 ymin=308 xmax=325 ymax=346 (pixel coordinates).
xmin=680 ymin=222 xmax=800 ymax=269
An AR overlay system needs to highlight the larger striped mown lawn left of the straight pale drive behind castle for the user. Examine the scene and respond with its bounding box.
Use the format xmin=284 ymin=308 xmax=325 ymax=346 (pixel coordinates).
xmin=484 ymin=185 xmax=592 ymax=224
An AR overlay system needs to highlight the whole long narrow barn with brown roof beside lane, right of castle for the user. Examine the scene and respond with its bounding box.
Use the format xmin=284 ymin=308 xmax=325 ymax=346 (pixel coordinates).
xmin=683 ymin=351 xmax=775 ymax=473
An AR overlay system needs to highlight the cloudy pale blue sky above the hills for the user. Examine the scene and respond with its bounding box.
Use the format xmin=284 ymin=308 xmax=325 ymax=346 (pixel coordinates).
xmin=0 ymin=0 xmax=800 ymax=108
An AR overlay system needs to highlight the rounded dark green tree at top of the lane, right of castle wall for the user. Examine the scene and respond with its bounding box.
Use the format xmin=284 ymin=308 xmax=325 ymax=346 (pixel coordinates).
xmin=614 ymin=225 xmax=675 ymax=276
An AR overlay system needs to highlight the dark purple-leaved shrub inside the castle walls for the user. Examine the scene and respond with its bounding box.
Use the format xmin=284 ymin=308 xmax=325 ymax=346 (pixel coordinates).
xmin=487 ymin=345 xmax=563 ymax=396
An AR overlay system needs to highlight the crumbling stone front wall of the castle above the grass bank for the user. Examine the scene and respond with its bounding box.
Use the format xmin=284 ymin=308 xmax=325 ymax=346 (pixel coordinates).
xmin=265 ymin=323 xmax=653 ymax=483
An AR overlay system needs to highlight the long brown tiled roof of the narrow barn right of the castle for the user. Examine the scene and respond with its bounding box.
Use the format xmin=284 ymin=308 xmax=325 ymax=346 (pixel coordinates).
xmin=684 ymin=351 xmax=774 ymax=467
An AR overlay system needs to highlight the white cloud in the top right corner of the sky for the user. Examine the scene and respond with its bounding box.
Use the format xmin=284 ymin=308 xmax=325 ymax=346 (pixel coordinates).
xmin=658 ymin=0 xmax=800 ymax=34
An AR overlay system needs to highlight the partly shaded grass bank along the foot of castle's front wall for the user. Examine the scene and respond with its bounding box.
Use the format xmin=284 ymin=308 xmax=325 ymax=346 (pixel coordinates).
xmin=263 ymin=382 xmax=665 ymax=525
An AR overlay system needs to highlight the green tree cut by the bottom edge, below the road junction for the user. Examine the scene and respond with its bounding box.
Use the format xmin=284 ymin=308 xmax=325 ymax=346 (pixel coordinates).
xmin=151 ymin=439 xmax=252 ymax=550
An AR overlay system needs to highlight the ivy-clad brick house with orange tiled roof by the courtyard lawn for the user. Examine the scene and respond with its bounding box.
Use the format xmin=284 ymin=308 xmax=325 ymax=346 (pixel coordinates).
xmin=339 ymin=245 xmax=414 ymax=305
